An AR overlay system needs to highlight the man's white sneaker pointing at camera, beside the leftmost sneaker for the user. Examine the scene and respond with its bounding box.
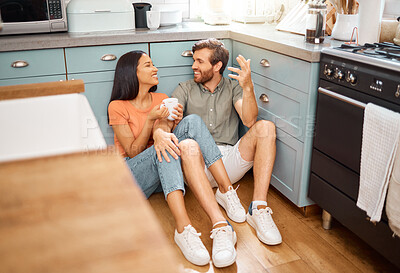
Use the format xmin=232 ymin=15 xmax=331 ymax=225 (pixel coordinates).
xmin=210 ymin=225 xmax=237 ymax=267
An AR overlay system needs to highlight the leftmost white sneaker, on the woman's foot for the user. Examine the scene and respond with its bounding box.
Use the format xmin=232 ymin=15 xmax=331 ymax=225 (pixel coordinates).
xmin=175 ymin=225 xmax=210 ymax=266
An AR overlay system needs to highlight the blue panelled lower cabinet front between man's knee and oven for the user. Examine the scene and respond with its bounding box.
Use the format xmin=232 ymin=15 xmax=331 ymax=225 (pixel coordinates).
xmin=271 ymin=126 xmax=303 ymax=204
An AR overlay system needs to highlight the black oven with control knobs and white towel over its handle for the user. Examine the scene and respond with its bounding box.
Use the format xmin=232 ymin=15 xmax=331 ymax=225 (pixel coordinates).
xmin=309 ymin=43 xmax=400 ymax=267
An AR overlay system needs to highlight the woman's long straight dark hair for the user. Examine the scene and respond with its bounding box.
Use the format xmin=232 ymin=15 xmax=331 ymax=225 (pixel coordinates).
xmin=107 ymin=50 xmax=157 ymax=121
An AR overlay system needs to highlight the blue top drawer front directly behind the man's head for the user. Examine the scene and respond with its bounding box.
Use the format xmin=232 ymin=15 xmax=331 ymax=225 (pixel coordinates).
xmin=150 ymin=40 xmax=232 ymax=68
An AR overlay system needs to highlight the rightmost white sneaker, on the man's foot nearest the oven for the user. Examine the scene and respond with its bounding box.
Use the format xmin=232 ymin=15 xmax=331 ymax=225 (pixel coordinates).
xmin=246 ymin=207 xmax=282 ymax=245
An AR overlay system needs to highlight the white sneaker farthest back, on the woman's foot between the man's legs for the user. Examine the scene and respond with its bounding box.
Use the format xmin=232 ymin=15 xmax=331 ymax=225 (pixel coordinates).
xmin=215 ymin=186 xmax=246 ymax=223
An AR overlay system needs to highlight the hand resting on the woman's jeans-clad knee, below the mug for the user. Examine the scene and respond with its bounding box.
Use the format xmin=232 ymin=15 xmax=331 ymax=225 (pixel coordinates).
xmin=153 ymin=129 xmax=181 ymax=162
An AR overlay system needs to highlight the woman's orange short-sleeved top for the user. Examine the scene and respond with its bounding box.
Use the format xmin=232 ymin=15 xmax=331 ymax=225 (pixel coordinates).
xmin=108 ymin=92 xmax=168 ymax=157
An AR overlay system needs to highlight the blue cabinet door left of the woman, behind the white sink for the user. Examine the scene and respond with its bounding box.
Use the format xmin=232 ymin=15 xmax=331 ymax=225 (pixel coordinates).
xmin=69 ymin=71 xmax=114 ymax=145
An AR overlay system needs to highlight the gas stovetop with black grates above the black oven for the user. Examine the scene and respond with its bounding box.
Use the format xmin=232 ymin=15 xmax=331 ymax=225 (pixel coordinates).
xmin=322 ymin=42 xmax=400 ymax=72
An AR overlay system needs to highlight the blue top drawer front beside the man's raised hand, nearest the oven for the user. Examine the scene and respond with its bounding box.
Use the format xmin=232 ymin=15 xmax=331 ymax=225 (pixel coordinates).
xmin=232 ymin=41 xmax=311 ymax=93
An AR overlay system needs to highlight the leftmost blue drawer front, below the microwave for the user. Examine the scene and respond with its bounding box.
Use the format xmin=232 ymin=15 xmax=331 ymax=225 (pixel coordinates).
xmin=0 ymin=49 xmax=65 ymax=79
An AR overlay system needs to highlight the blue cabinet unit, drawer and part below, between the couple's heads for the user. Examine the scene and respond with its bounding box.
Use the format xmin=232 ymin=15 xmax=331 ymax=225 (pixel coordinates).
xmin=150 ymin=40 xmax=232 ymax=96
